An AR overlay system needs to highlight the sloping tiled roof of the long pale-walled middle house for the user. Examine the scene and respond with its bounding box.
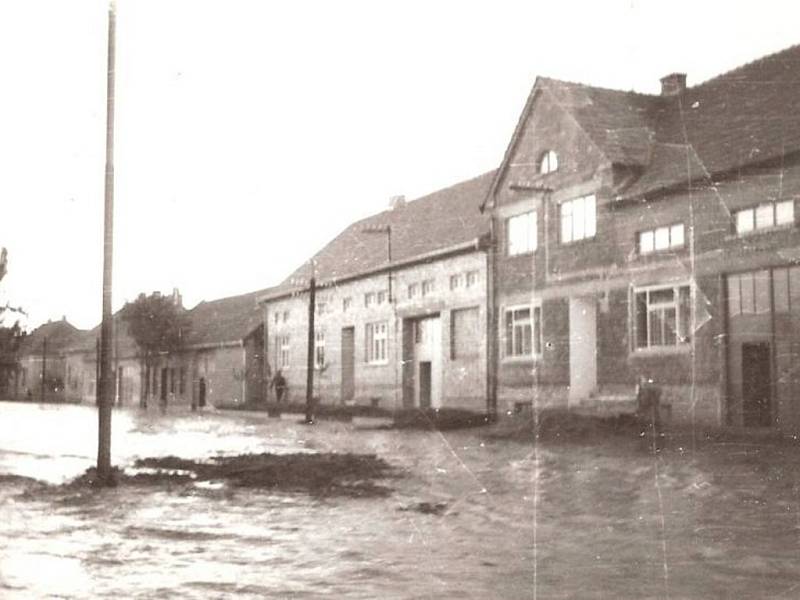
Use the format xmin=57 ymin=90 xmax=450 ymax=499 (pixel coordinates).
xmin=274 ymin=171 xmax=495 ymax=293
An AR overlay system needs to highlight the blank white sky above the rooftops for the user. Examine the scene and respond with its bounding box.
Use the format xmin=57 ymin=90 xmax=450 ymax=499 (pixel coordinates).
xmin=0 ymin=0 xmax=800 ymax=328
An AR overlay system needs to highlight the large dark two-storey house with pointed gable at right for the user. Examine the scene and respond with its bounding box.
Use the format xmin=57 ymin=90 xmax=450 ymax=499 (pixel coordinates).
xmin=486 ymin=47 xmax=800 ymax=429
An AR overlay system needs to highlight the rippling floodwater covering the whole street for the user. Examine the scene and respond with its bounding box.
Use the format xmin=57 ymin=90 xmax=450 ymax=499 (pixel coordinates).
xmin=0 ymin=403 xmax=800 ymax=599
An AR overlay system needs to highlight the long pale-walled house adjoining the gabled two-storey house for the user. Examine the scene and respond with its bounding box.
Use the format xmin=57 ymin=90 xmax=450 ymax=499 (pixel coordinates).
xmin=262 ymin=173 xmax=493 ymax=412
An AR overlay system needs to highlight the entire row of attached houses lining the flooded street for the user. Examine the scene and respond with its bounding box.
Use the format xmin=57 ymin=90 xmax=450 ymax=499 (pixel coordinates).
xmin=10 ymin=47 xmax=800 ymax=429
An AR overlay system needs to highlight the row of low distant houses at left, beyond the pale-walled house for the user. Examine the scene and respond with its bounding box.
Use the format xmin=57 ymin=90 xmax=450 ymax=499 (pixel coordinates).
xmin=9 ymin=290 xmax=264 ymax=407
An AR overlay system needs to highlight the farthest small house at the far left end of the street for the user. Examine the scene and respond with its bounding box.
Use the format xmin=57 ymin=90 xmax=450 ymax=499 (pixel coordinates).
xmin=13 ymin=317 xmax=83 ymax=401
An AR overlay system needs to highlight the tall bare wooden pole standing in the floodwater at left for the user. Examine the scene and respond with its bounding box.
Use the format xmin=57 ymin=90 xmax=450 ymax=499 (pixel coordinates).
xmin=97 ymin=0 xmax=116 ymax=485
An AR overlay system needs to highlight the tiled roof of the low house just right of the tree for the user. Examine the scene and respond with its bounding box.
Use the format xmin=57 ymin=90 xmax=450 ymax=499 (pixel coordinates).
xmin=186 ymin=290 xmax=268 ymax=346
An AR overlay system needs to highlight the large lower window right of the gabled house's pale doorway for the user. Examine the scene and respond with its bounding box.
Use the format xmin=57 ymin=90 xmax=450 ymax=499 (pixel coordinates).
xmin=634 ymin=285 xmax=692 ymax=350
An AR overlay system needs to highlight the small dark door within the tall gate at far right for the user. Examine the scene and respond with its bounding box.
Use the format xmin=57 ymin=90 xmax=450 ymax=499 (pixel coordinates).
xmin=742 ymin=342 xmax=772 ymax=427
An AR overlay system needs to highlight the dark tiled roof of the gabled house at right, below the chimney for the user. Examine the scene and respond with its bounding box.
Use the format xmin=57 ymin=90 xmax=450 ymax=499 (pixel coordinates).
xmin=498 ymin=45 xmax=800 ymax=203
